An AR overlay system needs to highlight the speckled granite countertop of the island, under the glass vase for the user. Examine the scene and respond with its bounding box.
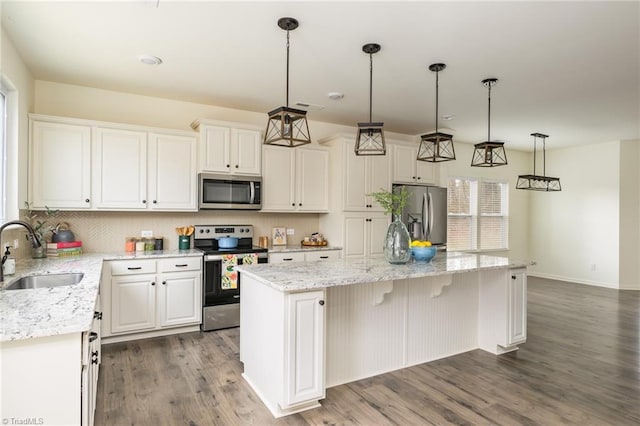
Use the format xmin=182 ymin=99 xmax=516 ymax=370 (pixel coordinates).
xmin=237 ymin=252 xmax=527 ymax=292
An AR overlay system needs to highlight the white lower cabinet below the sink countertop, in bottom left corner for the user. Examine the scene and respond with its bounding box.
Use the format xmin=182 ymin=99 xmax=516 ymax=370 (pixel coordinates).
xmin=0 ymin=297 xmax=101 ymax=426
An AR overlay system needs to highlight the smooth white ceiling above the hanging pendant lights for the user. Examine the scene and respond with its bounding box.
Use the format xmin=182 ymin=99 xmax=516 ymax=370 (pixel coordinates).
xmin=2 ymin=0 xmax=640 ymax=150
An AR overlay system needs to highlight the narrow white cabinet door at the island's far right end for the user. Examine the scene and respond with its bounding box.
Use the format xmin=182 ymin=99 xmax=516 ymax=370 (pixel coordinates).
xmin=507 ymin=269 xmax=527 ymax=345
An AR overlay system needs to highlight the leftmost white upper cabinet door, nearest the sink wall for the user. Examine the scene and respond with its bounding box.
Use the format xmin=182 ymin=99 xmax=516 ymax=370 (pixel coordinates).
xmin=29 ymin=121 xmax=91 ymax=210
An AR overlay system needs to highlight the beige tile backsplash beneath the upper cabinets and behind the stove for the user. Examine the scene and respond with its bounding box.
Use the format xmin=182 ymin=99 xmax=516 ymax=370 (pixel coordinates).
xmin=7 ymin=210 xmax=319 ymax=258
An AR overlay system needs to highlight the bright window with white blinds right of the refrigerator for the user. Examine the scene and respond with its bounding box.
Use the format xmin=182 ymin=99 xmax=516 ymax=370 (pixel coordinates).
xmin=447 ymin=178 xmax=509 ymax=250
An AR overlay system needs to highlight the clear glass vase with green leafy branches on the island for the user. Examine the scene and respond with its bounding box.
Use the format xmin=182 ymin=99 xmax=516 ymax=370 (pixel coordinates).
xmin=367 ymin=187 xmax=411 ymax=264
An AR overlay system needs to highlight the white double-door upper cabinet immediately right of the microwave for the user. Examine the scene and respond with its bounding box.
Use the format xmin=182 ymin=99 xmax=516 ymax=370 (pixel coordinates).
xmin=262 ymin=145 xmax=329 ymax=212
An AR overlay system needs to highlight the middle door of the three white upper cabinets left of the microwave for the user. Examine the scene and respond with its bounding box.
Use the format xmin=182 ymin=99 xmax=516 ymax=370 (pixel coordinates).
xmin=92 ymin=128 xmax=147 ymax=210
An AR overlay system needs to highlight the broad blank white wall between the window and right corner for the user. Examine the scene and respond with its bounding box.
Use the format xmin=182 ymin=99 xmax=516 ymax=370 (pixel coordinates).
xmin=529 ymin=141 xmax=624 ymax=287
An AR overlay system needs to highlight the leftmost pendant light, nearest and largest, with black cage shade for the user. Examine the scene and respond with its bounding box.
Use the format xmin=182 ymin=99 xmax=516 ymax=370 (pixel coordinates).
xmin=264 ymin=18 xmax=311 ymax=148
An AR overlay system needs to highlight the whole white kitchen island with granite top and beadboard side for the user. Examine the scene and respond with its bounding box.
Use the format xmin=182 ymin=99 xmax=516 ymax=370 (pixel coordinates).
xmin=238 ymin=252 xmax=527 ymax=417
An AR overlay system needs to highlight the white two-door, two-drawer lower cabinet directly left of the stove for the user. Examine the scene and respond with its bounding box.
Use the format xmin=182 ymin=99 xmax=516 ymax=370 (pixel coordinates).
xmin=102 ymin=257 xmax=202 ymax=337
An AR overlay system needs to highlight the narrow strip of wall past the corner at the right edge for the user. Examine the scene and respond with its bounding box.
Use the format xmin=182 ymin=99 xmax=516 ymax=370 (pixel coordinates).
xmin=619 ymin=140 xmax=640 ymax=290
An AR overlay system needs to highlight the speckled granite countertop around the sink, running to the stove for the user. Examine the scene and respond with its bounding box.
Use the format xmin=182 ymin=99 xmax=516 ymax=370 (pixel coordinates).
xmin=0 ymin=249 xmax=203 ymax=342
